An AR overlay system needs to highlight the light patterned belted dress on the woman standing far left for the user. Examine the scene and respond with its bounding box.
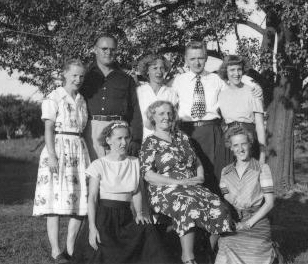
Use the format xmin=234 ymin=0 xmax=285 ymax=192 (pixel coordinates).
xmin=33 ymin=87 xmax=90 ymax=215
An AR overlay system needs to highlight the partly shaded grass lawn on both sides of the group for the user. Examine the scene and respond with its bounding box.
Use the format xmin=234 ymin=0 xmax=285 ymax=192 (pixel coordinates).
xmin=0 ymin=139 xmax=308 ymax=264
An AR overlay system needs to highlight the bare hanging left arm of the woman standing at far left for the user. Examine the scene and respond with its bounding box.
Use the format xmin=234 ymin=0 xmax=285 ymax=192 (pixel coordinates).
xmin=45 ymin=119 xmax=59 ymax=173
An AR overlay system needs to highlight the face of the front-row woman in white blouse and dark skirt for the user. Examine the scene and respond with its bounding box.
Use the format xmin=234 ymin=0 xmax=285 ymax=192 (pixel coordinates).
xmin=106 ymin=127 xmax=130 ymax=155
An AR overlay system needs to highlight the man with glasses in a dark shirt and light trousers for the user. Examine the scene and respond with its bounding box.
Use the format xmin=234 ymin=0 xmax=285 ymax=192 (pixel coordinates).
xmin=80 ymin=34 xmax=142 ymax=160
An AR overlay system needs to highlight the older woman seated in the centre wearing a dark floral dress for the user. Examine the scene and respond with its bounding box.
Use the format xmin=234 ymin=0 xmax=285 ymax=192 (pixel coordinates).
xmin=140 ymin=101 xmax=232 ymax=264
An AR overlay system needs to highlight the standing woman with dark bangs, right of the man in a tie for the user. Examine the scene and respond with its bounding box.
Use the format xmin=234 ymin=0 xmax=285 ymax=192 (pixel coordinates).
xmin=218 ymin=55 xmax=266 ymax=163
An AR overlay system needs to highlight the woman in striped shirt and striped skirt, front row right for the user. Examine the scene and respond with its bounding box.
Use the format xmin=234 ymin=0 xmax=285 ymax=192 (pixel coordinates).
xmin=215 ymin=126 xmax=276 ymax=264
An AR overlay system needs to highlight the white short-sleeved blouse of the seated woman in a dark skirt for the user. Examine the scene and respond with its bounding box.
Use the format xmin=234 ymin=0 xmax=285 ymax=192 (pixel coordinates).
xmin=86 ymin=156 xmax=140 ymax=198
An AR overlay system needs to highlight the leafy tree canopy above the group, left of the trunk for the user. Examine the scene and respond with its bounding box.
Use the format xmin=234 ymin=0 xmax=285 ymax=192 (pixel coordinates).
xmin=0 ymin=0 xmax=245 ymax=91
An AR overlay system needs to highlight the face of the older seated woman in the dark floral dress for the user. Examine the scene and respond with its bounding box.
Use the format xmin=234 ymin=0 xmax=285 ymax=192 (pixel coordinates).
xmin=153 ymin=104 xmax=174 ymax=131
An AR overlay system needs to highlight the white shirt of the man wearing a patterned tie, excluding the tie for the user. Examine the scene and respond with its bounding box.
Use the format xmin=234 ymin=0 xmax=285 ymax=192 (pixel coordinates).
xmin=172 ymin=71 xmax=226 ymax=121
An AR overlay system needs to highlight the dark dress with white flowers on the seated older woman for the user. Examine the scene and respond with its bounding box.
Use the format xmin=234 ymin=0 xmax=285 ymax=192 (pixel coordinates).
xmin=140 ymin=132 xmax=232 ymax=236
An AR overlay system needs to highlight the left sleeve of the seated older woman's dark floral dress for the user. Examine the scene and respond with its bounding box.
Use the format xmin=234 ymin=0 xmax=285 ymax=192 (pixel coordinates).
xmin=140 ymin=137 xmax=157 ymax=178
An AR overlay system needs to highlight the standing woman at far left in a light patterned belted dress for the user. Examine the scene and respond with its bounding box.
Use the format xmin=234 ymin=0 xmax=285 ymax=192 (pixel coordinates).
xmin=33 ymin=59 xmax=90 ymax=263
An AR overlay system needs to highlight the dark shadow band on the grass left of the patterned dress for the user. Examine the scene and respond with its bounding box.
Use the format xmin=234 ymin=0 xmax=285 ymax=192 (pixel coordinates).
xmin=0 ymin=156 xmax=38 ymax=204
